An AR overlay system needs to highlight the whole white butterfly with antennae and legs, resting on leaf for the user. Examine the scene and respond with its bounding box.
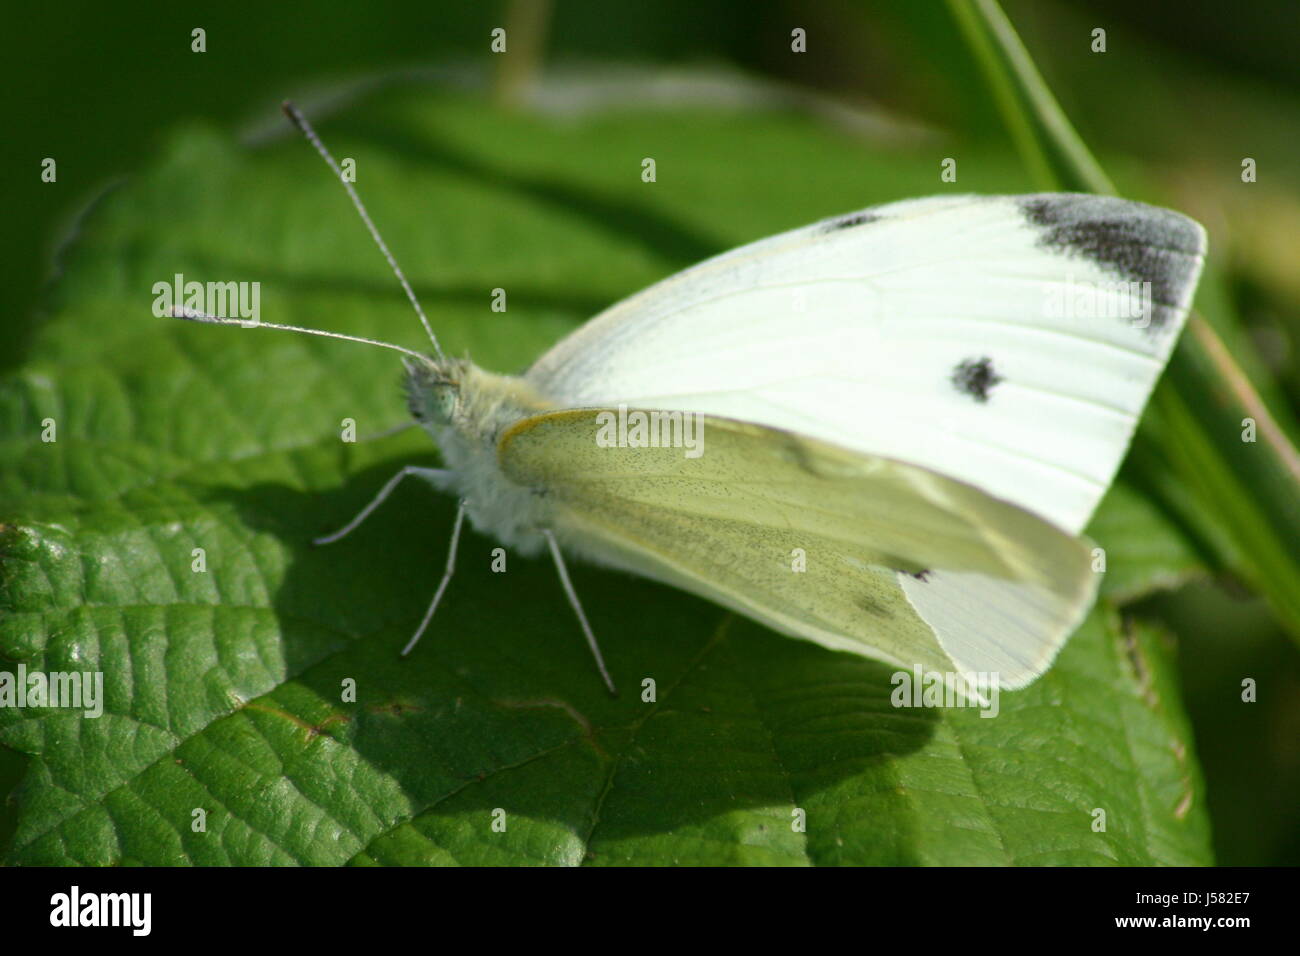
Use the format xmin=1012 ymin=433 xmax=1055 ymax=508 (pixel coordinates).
xmin=176 ymin=107 xmax=1205 ymax=689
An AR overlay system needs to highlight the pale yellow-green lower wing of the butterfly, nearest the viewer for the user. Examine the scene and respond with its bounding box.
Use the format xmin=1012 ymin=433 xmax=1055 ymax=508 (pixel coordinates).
xmin=498 ymin=410 xmax=1096 ymax=687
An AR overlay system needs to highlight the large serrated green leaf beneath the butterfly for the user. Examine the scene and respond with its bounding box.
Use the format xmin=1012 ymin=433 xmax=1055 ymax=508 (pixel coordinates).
xmin=0 ymin=91 xmax=1210 ymax=865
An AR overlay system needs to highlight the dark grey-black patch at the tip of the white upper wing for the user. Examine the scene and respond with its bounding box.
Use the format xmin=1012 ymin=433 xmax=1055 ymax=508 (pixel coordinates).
xmin=1019 ymin=193 xmax=1205 ymax=329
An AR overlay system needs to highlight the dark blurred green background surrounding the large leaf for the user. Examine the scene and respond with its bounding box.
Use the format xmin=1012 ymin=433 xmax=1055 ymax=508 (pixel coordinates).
xmin=0 ymin=0 xmax=1300 ymax=865
